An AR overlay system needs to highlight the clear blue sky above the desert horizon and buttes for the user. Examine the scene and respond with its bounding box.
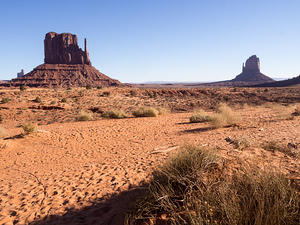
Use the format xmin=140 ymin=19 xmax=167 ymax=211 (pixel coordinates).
xmin=0 ymin=0 xmax=300 ymax=82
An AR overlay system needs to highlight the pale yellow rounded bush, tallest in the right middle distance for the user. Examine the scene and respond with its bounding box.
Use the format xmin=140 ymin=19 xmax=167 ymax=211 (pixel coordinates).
xmin=211 ymin=104 xmax=240 ymax=128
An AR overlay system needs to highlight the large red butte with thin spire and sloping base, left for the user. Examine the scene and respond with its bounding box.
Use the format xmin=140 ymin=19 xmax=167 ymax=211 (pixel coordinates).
xmin=8 ymin=32 xmax=122 ymax=87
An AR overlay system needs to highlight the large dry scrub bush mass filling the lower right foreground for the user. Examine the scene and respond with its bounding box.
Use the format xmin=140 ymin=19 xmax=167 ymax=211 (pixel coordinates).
xmin=125 ymin=146 xmax=300 ymax=225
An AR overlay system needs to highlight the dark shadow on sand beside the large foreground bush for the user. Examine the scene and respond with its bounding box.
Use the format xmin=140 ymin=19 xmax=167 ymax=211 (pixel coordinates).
xmin=29 ymin=187 xmax=145 ymax=225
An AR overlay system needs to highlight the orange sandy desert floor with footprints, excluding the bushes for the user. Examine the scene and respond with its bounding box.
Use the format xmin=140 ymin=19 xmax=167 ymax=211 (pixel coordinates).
xmin=0 ymin=89 xmax=300 ymax=225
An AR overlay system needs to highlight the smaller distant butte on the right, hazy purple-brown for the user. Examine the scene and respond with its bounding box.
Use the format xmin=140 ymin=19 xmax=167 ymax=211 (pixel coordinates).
xmin=231 ymin=55 xmax=274 ymax=84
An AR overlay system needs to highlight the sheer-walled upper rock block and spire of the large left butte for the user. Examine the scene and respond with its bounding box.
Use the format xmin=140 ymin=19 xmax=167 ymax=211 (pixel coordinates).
xmin=44 ymin=32 xmax=91 ymax=65
